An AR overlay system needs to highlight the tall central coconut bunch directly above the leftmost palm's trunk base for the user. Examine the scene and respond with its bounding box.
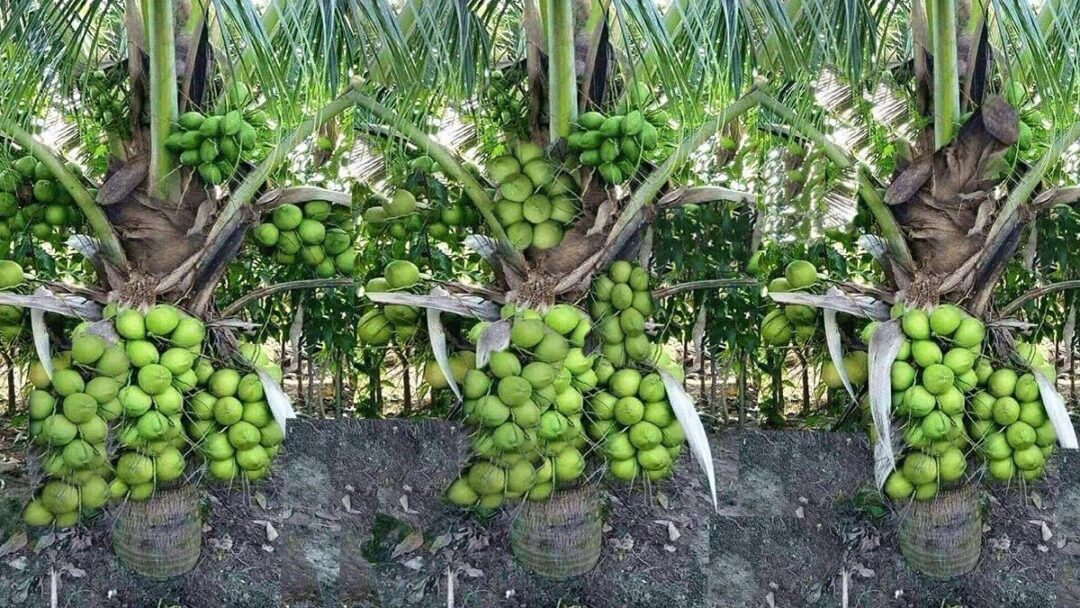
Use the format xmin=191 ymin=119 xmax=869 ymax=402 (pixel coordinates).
xmin=106 ymin=305 xmax=207 ymax=500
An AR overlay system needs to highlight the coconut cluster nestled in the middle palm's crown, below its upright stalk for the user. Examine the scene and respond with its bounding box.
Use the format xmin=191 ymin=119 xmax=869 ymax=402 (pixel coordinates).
xmin=486 ymin=141 xmax=578 ymax=251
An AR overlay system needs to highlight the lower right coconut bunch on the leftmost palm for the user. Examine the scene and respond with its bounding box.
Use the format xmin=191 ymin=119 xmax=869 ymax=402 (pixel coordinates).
xmin=187 ymin=342 xmax=284 ymax=482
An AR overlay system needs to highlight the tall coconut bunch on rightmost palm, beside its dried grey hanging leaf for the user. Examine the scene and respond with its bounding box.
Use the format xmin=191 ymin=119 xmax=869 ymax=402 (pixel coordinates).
xmin=862 ymin=303 xmax=990 ymax=501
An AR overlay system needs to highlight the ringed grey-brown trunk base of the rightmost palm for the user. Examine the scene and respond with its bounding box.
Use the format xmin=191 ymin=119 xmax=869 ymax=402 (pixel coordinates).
xmin=900 ymin=486 xmax=983 ymax=579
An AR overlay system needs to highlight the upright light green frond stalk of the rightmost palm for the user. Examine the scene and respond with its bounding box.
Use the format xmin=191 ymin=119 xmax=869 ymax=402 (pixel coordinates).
xmin=929 ymin=0 xmax=960 ymax=150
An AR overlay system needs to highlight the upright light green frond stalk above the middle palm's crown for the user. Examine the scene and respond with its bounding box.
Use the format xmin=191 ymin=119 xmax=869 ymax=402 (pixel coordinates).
xmin=548 ymin=0 xmax=578 ymax=141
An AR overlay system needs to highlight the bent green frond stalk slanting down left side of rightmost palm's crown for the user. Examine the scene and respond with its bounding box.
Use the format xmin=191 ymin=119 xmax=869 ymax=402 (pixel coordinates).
xmin=751 ymin=90 xmax=915 ymax=271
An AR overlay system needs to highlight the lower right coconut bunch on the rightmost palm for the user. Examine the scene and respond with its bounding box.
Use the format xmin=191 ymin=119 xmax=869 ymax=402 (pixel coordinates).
xmin=968 ymin=342 xmax=1057 ymax=482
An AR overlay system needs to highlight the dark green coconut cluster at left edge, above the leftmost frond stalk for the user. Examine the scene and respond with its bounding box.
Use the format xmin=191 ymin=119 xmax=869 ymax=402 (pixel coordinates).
xmin=0 ymin=154 xmax=82 ymax=256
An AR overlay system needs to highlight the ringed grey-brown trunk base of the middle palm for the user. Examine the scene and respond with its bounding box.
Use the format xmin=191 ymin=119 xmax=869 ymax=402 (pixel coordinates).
xmin=510 ymin=486 xmax=604 ymax=580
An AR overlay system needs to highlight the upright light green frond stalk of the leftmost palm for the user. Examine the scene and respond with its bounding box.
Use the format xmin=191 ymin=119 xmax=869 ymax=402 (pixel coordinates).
xmin=146 ymin=0 xmax=180 ymax=202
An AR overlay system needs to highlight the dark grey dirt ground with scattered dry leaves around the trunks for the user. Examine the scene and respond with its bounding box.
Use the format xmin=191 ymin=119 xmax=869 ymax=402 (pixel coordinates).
xmin=0 ymin=420 xmax=1080 ymax=608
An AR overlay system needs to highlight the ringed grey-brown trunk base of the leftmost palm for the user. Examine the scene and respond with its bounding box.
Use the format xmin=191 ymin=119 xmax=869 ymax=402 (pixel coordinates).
xmin=112 ymin=486 xmax=202 ymax=580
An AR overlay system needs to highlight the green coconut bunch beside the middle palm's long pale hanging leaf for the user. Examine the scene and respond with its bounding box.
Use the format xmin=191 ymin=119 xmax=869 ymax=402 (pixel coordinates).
xmin=588 ymin=367 xmax=686 ymax=482
